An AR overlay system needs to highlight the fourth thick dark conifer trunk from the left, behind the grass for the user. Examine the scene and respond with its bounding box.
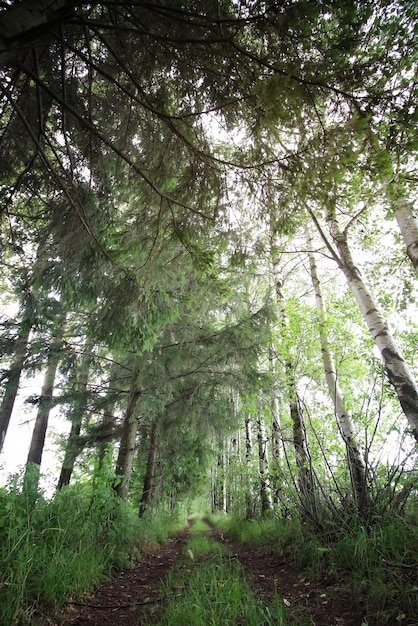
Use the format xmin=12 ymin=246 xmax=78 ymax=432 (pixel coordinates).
xmin=114 ymin=374 xmax=139 ymax=500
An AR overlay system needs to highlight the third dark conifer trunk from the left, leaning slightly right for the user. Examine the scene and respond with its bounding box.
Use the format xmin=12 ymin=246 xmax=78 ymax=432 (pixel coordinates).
xmin=57 ymin=341 xmax=93 ymax=489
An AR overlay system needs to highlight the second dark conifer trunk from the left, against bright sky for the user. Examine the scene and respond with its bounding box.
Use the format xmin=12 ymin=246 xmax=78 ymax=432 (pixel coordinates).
xmin=26 ymin=316 xmax=65 ymax=490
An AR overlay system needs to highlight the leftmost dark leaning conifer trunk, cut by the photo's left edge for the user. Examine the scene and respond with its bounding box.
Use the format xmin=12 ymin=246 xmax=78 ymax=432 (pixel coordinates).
xmin=0 ymin=292 xmax=34 ymax=452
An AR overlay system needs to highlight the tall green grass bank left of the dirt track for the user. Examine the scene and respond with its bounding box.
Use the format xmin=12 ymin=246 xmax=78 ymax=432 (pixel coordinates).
xmin=0 ymin=468 xmax=181 ymax=626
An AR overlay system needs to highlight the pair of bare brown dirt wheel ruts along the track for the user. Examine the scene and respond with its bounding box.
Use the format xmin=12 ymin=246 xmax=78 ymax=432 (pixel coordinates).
xmin=52 ymin=528 xmax=378 ymax=626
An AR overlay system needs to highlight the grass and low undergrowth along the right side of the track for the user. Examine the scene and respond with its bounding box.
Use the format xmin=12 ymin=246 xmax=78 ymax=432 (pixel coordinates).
xmin=209 ymin=516 xmax=418 ymax=626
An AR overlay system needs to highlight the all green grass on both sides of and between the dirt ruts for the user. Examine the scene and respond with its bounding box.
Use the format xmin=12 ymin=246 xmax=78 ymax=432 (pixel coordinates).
xmin=0 ymin=477 xmax=418 ymax=626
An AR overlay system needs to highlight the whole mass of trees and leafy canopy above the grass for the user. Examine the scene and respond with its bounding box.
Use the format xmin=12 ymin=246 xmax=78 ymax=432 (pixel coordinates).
xmin=0 ymin=0 xmax=418 ymax=528
